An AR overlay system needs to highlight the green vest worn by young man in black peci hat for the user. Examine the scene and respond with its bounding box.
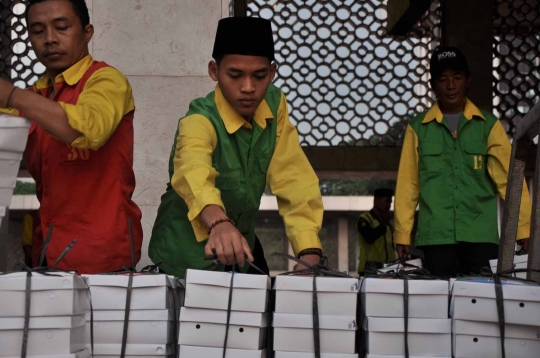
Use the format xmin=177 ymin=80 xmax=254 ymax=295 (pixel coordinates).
xmin=148 ymin=85 xmax=281 ymax=278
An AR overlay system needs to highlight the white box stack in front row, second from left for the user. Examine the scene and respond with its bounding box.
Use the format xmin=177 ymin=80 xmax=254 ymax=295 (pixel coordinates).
xmin=86 ymin=274 xmax=176 ymax=358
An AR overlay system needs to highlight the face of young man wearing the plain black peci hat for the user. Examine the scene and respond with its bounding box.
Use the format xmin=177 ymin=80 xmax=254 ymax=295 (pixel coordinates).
xmin=208 ymin=55 xmax=276 ymax=119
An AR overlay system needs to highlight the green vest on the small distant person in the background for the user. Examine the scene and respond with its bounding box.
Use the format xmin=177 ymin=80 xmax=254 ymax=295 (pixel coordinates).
xmin=358 ymin=212 xmax=396 ymax=273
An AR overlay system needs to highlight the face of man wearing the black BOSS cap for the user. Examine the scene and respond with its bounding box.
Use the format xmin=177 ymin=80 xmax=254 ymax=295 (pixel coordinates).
xmin=434 ymin=70 xmax=471 ymax=113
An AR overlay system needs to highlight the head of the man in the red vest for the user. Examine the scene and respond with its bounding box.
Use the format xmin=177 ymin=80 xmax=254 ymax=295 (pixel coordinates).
xmin=28 ymin=0 xmax=94 ymax=75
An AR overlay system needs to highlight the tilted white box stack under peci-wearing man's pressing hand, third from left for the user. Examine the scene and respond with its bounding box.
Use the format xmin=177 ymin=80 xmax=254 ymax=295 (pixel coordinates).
xmin=178 ymin=270 xmax=270 ymax=358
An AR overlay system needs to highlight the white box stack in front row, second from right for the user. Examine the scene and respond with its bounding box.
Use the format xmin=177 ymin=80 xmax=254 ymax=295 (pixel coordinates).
xmin=361 ymin=278 xmax=452 ymax=358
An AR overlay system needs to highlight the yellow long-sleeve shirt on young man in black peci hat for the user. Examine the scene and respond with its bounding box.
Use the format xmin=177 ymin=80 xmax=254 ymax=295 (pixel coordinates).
xmin=171 ymin=87 xmax=323 ymax=254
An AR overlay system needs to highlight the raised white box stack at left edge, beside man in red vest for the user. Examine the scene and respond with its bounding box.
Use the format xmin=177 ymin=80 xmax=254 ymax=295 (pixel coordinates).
xmin=0 ymin=114 xmax=30 ymax=226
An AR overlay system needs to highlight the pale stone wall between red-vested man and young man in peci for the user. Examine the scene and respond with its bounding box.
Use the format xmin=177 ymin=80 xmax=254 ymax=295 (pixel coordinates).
xmin=87 ymin=0 xmax=229 ymax=266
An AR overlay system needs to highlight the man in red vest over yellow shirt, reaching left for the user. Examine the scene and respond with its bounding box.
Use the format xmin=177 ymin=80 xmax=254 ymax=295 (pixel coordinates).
xmin=0 ymin=0 xmax=142 ymax=273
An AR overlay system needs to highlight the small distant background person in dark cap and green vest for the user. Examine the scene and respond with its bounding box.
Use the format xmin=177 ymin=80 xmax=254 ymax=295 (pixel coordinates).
xmin=356 ymin=188 xmax=395 ymax=274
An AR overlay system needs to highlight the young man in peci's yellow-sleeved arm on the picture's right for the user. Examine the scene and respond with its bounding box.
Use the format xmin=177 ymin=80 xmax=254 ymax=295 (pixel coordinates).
xmin=266 ymin=94 xmax=324 ymax=263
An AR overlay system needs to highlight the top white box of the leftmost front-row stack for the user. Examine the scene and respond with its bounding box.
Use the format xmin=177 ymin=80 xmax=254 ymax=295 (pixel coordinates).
xmin=0 ymin=272 xmax=90 ymax=317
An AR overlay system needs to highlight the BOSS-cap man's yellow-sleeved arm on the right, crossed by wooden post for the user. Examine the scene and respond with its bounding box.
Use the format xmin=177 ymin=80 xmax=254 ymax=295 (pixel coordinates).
xmin=487 ymin=121 xmax=531 ymax=240
